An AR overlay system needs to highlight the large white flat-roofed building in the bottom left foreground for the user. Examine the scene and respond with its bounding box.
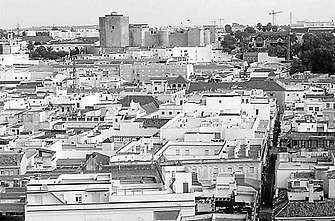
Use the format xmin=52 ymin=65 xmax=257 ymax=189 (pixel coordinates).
xmin=25 ymin=173 xmax=195 ymax=221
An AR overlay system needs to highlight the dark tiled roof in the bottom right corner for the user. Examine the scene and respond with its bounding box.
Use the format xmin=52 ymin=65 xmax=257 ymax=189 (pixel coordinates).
xmin=277 ymin=200 xmax=335 ymax=217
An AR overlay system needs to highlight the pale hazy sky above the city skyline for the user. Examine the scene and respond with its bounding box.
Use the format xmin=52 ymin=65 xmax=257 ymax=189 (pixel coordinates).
xmin=0 ymin=0 xmax=335 ymax=28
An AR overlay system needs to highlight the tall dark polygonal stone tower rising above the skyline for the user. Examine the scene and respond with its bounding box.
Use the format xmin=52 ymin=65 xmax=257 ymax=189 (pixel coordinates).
xmin=99 ymin=12 xmax=129 ymax=48
